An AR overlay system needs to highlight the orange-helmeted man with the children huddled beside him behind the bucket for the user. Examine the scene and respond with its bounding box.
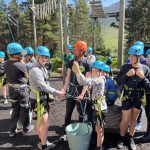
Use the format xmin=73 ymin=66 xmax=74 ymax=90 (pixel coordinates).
xmin=60 ymin=41 xmax=117 ymax=150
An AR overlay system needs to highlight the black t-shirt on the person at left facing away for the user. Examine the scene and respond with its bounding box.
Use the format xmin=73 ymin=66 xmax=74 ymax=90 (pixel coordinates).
xmin=4 ymin=60 xmax=27 ymax=84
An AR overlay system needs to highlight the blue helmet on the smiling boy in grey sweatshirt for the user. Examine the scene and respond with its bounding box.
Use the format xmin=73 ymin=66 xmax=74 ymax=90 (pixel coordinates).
xmin=35 ymin=46 xmax=50 ymax=57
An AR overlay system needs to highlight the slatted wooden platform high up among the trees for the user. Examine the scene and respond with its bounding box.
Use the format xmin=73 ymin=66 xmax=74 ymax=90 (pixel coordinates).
xmin=90 ymin=0 xmax=105 ymax=18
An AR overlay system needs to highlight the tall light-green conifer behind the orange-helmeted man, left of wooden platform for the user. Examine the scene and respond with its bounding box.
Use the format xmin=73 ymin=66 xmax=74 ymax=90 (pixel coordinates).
xmin=69 ymin=0 xmax=103 ymax=48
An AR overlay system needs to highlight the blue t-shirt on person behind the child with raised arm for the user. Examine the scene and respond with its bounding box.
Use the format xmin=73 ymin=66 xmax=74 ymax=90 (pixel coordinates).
xmin=105 ymin=77 xmax=117 ymax=101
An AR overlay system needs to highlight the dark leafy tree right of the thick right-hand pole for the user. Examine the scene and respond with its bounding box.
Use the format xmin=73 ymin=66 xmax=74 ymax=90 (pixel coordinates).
xmin=125 ymin=0 xmax=150 ymax=46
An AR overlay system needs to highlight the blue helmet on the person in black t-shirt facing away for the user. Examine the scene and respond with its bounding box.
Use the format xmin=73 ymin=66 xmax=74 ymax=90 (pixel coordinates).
xmin=7 ymin=43 xmax=23 ymax=54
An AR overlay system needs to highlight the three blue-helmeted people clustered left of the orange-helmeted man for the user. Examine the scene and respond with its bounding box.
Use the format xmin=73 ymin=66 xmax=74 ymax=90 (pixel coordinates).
xmin=0 ymin=43 xmax=63 ymax=150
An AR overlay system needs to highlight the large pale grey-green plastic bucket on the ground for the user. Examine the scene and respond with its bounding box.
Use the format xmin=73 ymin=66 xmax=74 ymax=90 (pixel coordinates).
xmin=66 ymin=123 xmax=92 ymax=150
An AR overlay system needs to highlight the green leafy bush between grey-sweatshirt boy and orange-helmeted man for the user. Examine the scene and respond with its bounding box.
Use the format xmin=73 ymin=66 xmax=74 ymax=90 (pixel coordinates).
xmin=50 ymin=58 xmax=62 ymax=72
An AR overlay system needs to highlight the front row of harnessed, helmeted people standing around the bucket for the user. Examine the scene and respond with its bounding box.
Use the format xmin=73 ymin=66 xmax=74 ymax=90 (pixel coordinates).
xmin=0 ymin=41 xmax=150 ymax=150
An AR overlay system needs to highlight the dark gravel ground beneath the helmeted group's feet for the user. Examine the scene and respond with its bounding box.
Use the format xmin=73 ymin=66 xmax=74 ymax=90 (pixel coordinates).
xmin=0 ymin=78 xmax=150 ymax=150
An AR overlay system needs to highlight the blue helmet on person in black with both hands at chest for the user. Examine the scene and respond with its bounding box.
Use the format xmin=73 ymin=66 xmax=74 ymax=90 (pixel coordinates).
xmin=128 ymin=45 xmax=144 ymax=56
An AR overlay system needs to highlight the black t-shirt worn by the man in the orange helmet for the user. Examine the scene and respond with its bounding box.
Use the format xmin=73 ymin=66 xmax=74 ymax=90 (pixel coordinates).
xmin=68 ymin=59 xmax=90 ymax=95
